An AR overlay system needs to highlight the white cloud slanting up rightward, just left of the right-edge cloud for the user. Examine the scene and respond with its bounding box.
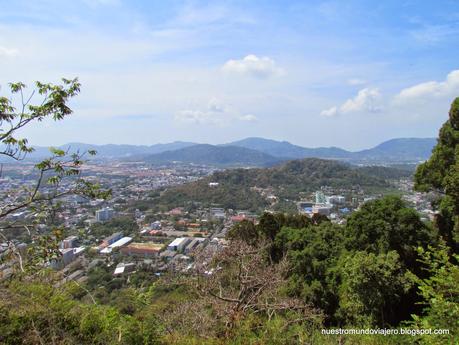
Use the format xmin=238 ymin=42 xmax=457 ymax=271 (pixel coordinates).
xmin=320 ymin=88 xmax=381 ymax=117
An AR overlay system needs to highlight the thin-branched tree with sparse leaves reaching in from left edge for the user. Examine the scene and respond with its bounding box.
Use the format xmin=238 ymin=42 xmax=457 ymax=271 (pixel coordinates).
xmin=0 ymin=79 xmax=110 ymax=271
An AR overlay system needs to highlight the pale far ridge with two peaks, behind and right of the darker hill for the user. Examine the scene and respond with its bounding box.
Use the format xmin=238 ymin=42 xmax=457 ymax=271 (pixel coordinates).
xmin=227 ymin=138 xmax=436 ymax=162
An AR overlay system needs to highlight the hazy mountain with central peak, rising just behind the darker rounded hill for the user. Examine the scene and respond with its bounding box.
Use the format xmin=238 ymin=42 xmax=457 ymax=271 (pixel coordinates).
xmin=227 ymin=138 xmax=349 ymax=159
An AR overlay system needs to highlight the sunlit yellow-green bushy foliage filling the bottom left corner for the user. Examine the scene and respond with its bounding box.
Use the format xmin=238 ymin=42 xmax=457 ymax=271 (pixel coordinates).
xmin=0 ymin=282 xmax=164 ymax=345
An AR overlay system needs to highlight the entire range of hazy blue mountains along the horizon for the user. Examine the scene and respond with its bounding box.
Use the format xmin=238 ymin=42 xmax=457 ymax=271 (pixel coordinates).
xmin=6 ymin=137 xmax=436 ymax=166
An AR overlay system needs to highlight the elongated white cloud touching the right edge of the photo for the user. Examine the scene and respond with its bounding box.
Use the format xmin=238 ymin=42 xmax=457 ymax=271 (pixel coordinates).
xmin=395 ymin=70 xmax=459 ymax=103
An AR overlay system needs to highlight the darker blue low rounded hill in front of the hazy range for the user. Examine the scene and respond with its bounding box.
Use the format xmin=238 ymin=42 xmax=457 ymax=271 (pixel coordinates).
xmin=144 ymin=144 xmax=280 ymax=167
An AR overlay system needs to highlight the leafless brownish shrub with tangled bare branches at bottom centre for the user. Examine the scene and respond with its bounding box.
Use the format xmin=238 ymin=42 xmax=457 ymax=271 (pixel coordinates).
xmin=192 ymin=240 xmax=321 ymax=336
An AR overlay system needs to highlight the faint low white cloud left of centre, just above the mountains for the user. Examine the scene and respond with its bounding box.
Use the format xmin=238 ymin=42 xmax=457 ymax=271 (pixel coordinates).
xmin=175 ymin=99 xmax=257 ymax=126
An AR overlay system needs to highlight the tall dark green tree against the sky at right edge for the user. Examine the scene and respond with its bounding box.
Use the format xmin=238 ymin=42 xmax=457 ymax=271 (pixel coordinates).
xmin=414 ymin=97 xmax=459 ymax=253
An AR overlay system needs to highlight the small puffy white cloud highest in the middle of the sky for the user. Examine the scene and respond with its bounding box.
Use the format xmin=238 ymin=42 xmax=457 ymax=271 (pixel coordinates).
xmin=222 ymin=54 xmax=283 ymax=79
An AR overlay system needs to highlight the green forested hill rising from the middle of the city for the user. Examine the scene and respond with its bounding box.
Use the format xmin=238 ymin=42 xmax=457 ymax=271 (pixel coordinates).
xmin=155 ymin=158 xmax=411 ymax=211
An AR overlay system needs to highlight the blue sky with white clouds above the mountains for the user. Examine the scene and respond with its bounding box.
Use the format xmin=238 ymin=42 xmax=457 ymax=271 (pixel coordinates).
xmin=0 ymin=0 xmax=459 ymax=150
